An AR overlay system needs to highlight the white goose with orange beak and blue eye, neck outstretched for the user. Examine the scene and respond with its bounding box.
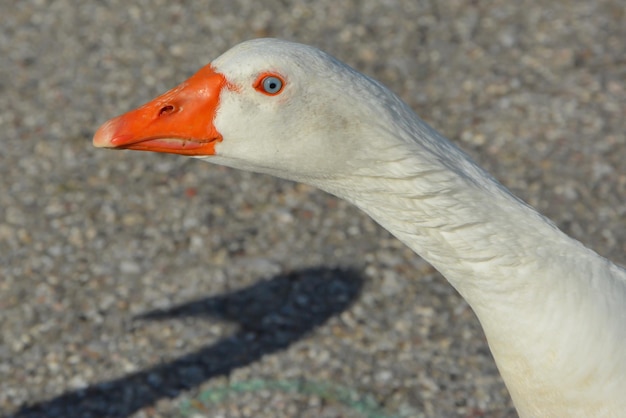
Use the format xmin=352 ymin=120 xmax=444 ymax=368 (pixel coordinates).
xmin=94 ymin=39 xmax=626 ymax=417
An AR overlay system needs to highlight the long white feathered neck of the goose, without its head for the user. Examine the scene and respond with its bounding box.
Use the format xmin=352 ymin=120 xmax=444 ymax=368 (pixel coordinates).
xmin=312 ymin=122 xmax=626 ymax=417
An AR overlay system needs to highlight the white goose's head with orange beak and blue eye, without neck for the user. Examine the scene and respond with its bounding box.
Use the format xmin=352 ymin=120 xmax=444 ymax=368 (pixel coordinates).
xmin=94 ymin=39 xmax=420 ymax=186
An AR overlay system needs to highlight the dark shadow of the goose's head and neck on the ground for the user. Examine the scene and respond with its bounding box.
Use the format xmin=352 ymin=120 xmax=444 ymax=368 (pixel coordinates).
xmin=9 ymin=267 xmax=364 ymax=418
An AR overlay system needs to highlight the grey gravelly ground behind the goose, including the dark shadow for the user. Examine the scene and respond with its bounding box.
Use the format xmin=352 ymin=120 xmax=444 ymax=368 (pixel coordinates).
xmin=0 ymin=0 xmax=626 ymax=418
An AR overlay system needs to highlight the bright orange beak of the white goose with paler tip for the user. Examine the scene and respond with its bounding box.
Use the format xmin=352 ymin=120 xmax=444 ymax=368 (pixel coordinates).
xmin=93 ymin=65 xmax=226 ymax=155
